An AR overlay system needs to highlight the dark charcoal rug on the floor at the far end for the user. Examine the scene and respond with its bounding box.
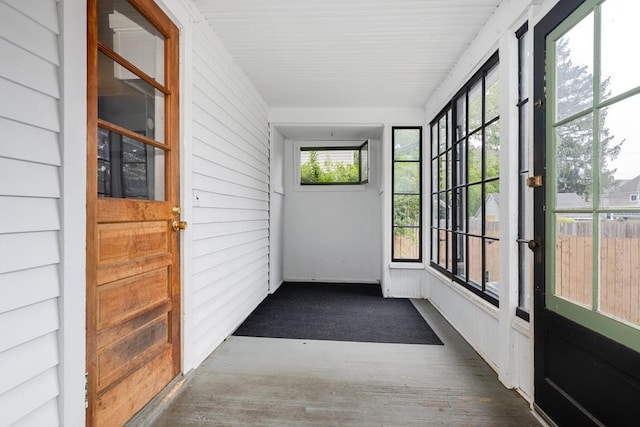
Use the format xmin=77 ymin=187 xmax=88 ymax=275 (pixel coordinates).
xmin=234 ymin=283 xmax=442 ymax=345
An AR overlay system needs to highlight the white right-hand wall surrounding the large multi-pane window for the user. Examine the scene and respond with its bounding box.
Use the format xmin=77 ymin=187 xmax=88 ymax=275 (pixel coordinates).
xmin=425 ymin=0 xmax=557 ymax=400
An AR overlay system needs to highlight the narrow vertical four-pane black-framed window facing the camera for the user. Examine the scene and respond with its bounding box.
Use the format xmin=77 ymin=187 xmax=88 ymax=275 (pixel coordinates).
xmin=391 ymin=127 xmax=422 ymax=262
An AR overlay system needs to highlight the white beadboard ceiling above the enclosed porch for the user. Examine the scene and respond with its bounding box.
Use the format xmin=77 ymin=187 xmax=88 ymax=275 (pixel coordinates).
xmin=194 ymin=0 xmax=502 ymax=108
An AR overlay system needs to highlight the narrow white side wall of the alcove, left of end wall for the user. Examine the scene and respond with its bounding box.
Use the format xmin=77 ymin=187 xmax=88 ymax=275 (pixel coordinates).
xmin=269 ymin=127 xmax=285 ymax=293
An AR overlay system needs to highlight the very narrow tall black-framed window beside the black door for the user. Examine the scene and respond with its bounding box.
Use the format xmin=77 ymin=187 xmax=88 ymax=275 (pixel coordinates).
xmin=516 ymin=24 xmax=534 ymax=321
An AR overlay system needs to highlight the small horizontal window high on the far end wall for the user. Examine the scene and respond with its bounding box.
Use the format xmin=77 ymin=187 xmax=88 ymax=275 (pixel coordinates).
xmin=299 ymin=141 xmax=369 ymax=185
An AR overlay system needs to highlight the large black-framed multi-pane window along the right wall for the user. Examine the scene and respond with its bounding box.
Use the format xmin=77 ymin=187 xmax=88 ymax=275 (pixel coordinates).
xmin=430 ymin=52 xmax=500 ymax=305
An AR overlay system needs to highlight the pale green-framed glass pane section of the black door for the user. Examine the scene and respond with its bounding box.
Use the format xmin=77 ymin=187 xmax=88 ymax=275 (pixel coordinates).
xmin=545 ymin=0 xmax=640 ymax=351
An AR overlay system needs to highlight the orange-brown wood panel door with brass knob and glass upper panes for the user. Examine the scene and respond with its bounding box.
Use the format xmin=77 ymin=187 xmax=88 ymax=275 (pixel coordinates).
xmin=87 ymin=0 xmax=184 ymax=427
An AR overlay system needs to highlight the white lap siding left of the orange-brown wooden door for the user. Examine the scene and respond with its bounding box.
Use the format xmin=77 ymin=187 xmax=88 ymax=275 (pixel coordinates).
xmin=0 ymin=0 xmax=61 ymax=426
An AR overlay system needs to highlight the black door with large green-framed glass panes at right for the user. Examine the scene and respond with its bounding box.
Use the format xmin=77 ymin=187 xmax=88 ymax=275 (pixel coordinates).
xmin=534 ymin=0 xmax=640 ymax=426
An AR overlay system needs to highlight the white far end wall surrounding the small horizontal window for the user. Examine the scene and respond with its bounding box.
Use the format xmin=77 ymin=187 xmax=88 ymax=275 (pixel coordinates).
xmin=284 ymin=140 xmax=382 ymax=283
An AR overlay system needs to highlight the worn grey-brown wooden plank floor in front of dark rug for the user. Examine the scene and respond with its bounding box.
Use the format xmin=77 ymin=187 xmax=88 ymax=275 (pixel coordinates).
xmin=144 ymin=301 xmax=541 ymax=427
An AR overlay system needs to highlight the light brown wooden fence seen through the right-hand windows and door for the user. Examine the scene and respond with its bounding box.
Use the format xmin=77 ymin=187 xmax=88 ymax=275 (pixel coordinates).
xmin=438 ymin=221 xmax=640 ymax=324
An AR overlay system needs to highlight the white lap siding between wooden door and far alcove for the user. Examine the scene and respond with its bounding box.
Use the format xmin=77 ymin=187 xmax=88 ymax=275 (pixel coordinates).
xmin=191 ymin=22 xmax=269 ymax=364
